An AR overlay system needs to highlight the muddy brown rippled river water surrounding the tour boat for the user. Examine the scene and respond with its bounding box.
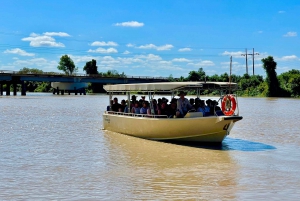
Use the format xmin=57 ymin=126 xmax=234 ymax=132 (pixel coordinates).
xmin=0 ymin=93 xmax=300 ymax=200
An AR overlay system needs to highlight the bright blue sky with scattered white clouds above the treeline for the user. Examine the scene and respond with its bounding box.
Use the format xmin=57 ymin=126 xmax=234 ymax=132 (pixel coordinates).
xmin=0 ymin=0 xmax=300 ymax=77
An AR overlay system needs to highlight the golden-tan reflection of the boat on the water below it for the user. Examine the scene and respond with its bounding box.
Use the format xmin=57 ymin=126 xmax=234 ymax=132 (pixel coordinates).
xmin=103 ymin=131 xmax=239 ymax=199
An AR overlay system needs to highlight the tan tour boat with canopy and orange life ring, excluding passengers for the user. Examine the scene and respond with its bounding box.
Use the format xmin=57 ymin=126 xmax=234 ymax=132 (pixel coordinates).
xmin=103 ymin=82 xmax=243 ymax=143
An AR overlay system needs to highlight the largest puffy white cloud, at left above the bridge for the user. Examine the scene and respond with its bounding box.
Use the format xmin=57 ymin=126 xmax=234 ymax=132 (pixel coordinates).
xmin=22 ymin=32 xmax=69 ymax=47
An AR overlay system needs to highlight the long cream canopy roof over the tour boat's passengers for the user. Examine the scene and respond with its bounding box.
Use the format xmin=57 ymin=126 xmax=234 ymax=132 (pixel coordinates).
xmin=103 ymin=82 xmax=237 ymax=92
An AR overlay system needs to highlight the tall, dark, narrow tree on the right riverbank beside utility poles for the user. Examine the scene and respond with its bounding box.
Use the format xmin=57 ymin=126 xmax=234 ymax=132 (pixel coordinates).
xmin=261 ymin=56 xmax=280 ymax=97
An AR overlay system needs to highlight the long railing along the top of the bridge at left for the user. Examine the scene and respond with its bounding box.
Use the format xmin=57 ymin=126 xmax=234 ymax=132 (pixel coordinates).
xmin=0 ymin=70 xmax=169 ymax=80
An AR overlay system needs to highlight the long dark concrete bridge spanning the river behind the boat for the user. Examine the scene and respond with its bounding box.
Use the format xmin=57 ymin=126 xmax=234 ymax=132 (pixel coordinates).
xmin=0 ymin=70 xmax=168 ymax=96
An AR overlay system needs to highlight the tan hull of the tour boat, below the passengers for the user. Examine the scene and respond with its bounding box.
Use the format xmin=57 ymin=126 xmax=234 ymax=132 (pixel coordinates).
xmin=103 ymin=113 xmax=242 ymax=143
